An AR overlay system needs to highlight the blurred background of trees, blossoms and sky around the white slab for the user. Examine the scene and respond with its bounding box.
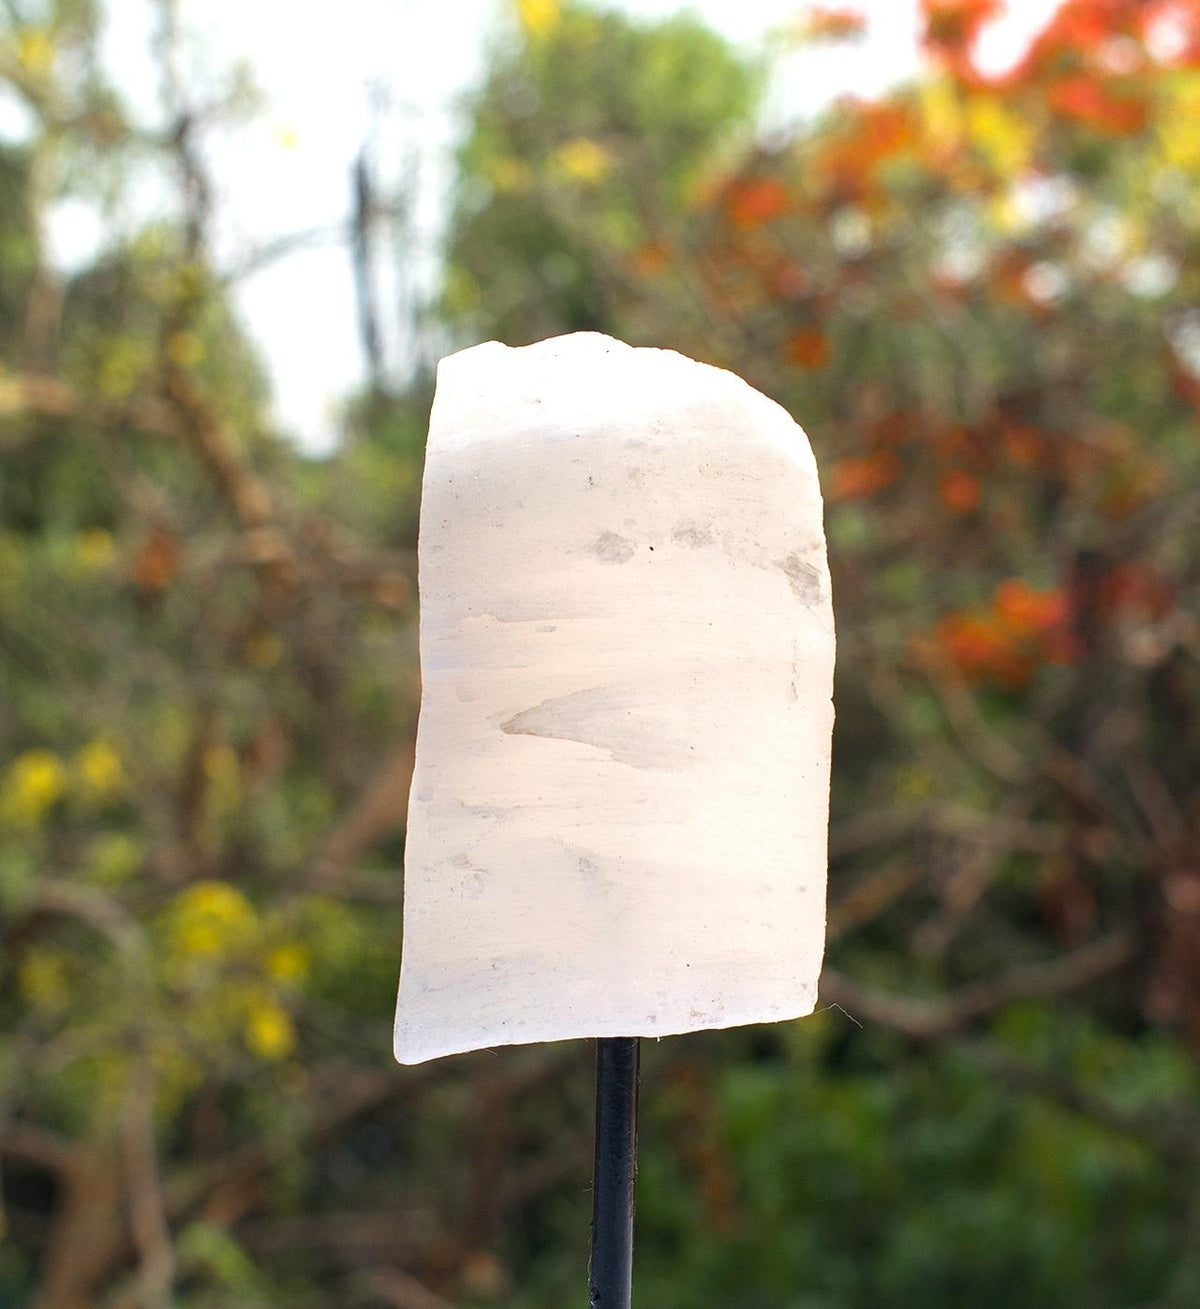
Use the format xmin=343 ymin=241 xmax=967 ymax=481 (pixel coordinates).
xmin=0 ymin=0 xmax=1200 ymax=1309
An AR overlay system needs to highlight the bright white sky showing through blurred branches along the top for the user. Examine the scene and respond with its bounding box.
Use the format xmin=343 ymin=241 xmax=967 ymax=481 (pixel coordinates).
xmin=21 ymin=0 xmax=1055 ymax=452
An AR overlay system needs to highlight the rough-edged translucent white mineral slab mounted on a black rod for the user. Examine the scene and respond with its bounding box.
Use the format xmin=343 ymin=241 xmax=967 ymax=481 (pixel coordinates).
xmin=395 ymin=332 xmax=834 ymax=1063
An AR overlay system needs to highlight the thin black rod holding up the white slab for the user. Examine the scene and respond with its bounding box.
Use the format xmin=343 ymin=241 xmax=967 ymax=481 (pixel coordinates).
xmin=588 ymin=1037 xmax=641 ymax=1309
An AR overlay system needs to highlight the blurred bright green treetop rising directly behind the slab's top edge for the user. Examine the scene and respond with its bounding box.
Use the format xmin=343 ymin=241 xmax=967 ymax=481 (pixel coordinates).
xmin=444 ymin=5 xmax=759 ymax=342
